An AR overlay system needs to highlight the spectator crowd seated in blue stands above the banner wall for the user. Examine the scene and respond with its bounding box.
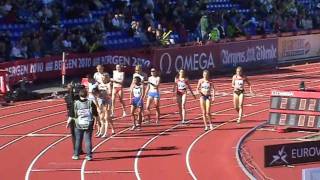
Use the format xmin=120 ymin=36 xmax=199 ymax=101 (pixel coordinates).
xmin=0 ymin=0 xmax=320 ymax=62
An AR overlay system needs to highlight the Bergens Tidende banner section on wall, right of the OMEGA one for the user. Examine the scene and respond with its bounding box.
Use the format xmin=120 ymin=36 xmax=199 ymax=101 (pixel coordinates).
xmin=219 ymin=38 xmax=278 ymax=69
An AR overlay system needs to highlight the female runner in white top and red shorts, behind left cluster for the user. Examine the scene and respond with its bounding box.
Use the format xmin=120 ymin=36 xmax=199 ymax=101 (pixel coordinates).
xmin=111 ymin=64 xmax=127 ymax=117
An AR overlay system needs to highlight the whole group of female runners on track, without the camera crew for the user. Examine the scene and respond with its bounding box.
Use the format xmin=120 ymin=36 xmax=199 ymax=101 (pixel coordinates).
xmin=83 ymin=65 xmax=251 ymax=137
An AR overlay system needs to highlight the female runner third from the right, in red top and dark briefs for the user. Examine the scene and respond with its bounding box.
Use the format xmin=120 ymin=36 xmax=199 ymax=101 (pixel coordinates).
xmin=173 ymin=69 xmax=196 ymax=124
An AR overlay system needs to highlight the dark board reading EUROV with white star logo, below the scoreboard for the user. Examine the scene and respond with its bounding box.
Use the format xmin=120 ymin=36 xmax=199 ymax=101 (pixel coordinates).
xmin=264 ymin=141 xmax=320 ymax=167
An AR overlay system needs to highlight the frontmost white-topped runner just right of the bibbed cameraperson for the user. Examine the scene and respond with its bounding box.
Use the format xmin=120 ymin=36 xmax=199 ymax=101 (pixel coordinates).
xmin=99 ymin=73 xmax=115 ymax=138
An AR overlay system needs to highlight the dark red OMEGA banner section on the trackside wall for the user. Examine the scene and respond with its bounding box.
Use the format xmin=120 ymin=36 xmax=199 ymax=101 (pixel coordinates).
xmin=154 ymin=45 xmax=216 ymax=77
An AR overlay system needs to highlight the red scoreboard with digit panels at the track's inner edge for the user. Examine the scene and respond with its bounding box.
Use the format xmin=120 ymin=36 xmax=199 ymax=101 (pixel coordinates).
xmin=268 ymin=90 xmax=320 ymax=129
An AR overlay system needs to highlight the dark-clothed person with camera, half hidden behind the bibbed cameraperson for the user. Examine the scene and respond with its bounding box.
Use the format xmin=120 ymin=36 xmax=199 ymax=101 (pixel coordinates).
xmin=64 ymin=83 xmax=84 ymax=154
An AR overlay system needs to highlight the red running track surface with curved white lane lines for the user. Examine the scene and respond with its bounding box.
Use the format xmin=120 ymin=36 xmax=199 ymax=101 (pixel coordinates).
xmin=0 ymin=64 xmax=320 ymax=180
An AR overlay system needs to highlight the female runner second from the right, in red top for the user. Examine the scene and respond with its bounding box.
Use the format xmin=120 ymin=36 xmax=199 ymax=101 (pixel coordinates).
xmin=197 ymin=70 xmax=215 ymax=131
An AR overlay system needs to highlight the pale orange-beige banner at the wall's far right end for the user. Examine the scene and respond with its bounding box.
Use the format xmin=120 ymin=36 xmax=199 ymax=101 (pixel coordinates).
xmin=278 ymin=34 xmax=320 ymax=62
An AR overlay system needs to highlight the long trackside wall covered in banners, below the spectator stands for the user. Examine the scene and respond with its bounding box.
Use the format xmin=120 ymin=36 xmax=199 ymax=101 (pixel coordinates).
xmin=0 ymin=33 xmax=320 ymax=84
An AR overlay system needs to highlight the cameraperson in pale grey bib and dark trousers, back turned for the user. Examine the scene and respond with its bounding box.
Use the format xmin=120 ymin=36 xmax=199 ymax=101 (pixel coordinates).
xmin=72 ymin=89 xmax=99 ymax=161
